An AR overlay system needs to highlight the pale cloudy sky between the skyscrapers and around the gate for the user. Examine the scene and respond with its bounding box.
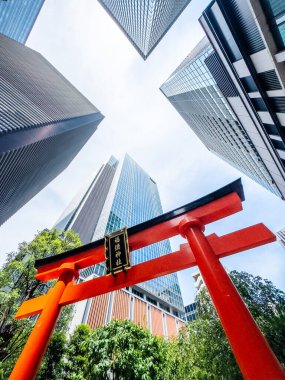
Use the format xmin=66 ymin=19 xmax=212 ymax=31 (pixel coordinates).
xmin=0 ymin=0 xmax=285 ymax=304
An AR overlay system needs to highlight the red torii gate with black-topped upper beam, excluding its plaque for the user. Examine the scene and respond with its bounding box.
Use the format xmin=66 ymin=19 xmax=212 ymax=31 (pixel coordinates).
xmin=9 ymin=180 xmax=285 ymax=380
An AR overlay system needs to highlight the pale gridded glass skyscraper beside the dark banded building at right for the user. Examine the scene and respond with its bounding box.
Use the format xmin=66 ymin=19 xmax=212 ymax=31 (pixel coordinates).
xmin=161 ymin=37 xmax=285 ymax=198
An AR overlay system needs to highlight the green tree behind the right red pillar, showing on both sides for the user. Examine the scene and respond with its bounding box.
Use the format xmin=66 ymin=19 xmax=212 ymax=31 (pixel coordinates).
xmin=168 ymin=271 xmax=285 ymax=380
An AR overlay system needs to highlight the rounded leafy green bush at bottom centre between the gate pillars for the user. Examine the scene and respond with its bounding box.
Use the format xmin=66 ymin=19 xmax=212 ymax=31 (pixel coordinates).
xmin=66 ymin=321 xmax=167 ymax=380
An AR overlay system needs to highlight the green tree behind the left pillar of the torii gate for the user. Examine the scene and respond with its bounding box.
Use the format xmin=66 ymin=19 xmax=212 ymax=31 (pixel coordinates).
xmin=0 ymin=229 xmax=81 ymax=378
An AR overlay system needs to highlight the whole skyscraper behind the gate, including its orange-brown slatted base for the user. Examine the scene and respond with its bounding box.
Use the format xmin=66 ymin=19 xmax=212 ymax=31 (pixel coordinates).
xmin=55 ymin=155 xmax=184 ymax=336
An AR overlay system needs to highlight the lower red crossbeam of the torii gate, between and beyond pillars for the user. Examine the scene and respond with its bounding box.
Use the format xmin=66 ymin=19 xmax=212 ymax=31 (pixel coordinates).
xmin=15 ymin=223 xmax=276 ymax=319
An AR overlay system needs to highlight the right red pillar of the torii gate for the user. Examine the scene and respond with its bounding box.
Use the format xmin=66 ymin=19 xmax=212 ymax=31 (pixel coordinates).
xmin=181 ymin=219 xmax=285 ymax=380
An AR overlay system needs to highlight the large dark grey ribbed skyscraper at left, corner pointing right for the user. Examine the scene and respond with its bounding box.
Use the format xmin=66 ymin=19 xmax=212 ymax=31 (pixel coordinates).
xmin=0 ymin=35 xmax=103 ymax=225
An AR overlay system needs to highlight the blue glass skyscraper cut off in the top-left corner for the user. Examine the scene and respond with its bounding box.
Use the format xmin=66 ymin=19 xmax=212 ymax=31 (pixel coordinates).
xmin=0 ymin=0 xmax=44 ymax=44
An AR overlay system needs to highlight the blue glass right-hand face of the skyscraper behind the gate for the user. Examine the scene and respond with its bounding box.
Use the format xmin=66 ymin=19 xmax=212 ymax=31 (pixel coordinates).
xmin=105 ymin=155 xmax=183 ymax=309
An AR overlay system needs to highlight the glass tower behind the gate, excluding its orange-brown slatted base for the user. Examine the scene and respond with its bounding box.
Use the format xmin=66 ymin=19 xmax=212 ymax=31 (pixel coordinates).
xmin=55 ymin=155 xmax=184 ymax=315
